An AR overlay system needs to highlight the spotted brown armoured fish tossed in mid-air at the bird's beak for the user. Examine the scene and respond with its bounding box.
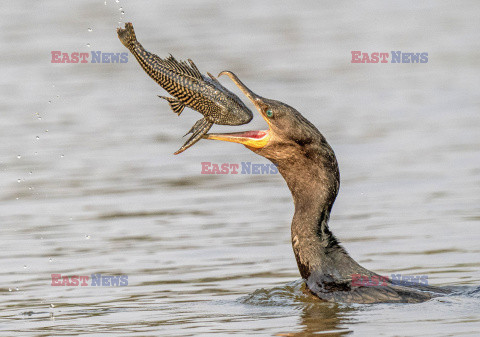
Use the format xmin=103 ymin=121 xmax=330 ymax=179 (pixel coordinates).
xmin=117 ymin=22 xmax=253 ymax=155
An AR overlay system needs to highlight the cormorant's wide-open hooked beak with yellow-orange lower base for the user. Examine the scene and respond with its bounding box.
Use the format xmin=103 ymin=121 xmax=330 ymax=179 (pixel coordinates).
xmin=203 ymin=71 xmax=271 ymax=150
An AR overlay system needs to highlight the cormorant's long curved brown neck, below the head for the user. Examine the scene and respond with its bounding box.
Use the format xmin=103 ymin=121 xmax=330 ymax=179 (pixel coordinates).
xmin=266 ymin=142 xmax=368 ymax=285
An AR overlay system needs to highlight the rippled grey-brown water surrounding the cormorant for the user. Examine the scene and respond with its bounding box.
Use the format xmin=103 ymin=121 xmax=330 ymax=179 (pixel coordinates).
xmin=0 ymin=0 xmax=480 ymax=336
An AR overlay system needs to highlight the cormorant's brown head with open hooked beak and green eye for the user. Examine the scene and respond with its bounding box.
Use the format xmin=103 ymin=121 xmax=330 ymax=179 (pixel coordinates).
xmin=204 ymin=71 xmax=334 ymax=164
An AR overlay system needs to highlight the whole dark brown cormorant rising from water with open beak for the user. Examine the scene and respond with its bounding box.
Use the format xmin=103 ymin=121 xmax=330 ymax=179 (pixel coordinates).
xmin=204 ymin=71 xmax=450 ymax=303
